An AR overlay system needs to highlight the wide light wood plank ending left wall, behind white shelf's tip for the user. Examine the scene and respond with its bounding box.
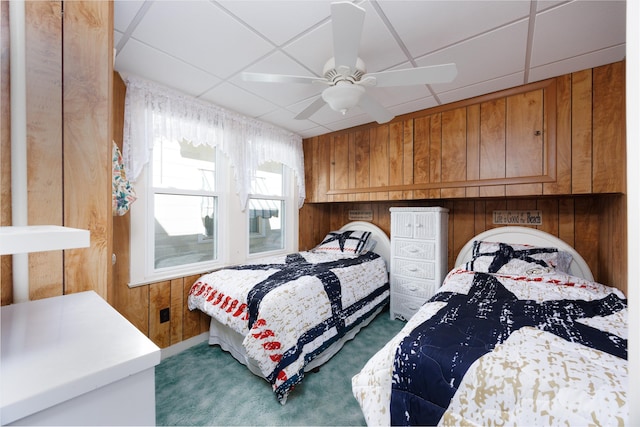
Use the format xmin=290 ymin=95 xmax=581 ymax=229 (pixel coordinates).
xmin=63 ymin=1 xmax=113 ymax=299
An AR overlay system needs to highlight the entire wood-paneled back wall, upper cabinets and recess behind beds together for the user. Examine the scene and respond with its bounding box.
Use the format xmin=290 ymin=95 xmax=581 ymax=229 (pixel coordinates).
xmin=299 ymin=62 xmax=627 ymax=298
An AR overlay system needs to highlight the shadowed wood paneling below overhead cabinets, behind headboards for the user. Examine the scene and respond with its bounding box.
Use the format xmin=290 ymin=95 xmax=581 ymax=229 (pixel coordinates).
xmin=299 ymin=194 xmax=627 ymax=292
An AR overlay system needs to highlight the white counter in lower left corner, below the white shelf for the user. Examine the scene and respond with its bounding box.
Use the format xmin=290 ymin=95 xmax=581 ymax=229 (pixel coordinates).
xmin=0 ymin=291 xmax=160 ymax=425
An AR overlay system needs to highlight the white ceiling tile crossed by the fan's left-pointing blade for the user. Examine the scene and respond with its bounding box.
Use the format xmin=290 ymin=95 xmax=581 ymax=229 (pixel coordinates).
xmin=230 ymin=51 xmax=327 ymax=107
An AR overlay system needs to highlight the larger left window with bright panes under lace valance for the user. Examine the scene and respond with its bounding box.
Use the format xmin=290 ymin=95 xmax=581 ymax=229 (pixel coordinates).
xmin=139 ymin=140 xmax=219 ymax=276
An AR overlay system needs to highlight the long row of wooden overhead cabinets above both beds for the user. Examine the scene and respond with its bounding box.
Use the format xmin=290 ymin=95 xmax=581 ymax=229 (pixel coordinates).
xmin=304 ymin=62 xmax=626 ymax=203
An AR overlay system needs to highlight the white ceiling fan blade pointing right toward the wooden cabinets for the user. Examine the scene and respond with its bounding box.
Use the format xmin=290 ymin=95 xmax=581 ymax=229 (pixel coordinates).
xmin=362 ymin=64 xmax=458 ymax=87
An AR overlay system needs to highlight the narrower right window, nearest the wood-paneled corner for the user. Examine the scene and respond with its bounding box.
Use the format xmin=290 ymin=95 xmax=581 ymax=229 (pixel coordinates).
xmin=248 ymin=162 xmax=286 ymax=254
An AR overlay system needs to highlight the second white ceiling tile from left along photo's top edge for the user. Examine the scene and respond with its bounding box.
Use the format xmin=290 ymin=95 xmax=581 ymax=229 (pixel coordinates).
xmin=127 ymin=1 xmax=273 ymax=79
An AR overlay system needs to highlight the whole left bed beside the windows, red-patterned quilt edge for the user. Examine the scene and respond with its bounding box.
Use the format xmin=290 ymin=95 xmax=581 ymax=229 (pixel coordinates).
xmin=188 ymin=221 xmax=390 ymax=404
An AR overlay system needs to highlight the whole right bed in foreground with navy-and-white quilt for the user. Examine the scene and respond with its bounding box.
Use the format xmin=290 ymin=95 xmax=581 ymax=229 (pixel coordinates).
xmin=352 ymin=227 xmax=629 ymax=425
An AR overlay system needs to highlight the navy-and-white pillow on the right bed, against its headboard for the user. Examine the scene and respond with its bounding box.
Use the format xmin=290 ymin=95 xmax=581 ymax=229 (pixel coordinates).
xmin=465 ymin=240 xmax=573 ymax=275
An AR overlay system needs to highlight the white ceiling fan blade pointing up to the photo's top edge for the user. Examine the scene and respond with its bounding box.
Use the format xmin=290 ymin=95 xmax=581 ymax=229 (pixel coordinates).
xmin=331 ymin=1 xmax=365 ymax=69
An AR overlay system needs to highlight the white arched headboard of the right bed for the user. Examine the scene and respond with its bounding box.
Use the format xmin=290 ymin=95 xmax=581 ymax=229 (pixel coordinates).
xmin=456 ymin=227 xmax=593 ymax=281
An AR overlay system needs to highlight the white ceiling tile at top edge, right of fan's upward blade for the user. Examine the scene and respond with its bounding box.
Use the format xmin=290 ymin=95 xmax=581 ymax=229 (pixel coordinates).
xmin=378 ymin=0 xmax=529 ymax=57
